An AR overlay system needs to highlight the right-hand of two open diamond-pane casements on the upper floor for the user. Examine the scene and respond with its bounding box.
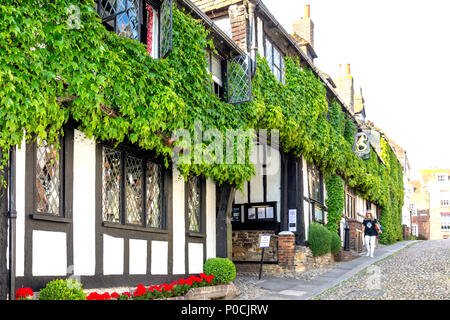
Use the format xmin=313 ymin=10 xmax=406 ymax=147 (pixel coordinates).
xmin=227 ymin=54 xmax=252 ymax=104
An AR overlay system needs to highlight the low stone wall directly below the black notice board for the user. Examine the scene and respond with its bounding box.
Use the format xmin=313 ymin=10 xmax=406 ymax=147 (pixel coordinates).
xmin=232 ymin=230 xmax=278 ymax=262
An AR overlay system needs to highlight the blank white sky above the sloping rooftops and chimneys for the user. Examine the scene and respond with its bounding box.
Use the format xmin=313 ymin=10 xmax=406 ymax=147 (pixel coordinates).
xmin=263 ymin=0 xmax=450 ymax=169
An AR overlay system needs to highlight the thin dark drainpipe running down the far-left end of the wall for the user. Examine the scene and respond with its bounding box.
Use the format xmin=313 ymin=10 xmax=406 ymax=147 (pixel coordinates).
xmin=8 ymin=147 xmax=17 ymax=300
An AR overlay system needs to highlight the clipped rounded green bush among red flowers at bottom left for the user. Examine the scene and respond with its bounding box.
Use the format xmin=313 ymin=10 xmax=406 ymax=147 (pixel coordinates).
xmin=39 ymin=279 xmax=86 ymax=300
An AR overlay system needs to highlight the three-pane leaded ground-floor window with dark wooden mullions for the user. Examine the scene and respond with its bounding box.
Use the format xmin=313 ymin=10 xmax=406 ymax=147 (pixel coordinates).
xmin=103 ymin=147 xmax=164 ymax=229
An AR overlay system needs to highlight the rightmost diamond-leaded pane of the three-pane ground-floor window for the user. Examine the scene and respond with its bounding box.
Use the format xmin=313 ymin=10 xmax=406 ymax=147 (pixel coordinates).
xmin=145 ymin=162 xmax=163 ymax=228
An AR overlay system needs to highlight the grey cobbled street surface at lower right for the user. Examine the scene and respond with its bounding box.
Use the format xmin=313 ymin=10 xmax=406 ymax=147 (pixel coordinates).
xmin=315 ymin=240 xmax=450 ymax=300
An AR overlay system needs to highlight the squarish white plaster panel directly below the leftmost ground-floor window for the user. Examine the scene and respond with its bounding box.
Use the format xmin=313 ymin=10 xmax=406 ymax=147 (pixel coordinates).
xmin=32 ymin=230 xmax=67 ymax=276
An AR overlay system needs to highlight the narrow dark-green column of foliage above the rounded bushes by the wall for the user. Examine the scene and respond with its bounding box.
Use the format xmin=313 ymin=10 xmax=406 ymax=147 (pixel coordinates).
xmin=325 ymin=174 xmax=345 ymax=231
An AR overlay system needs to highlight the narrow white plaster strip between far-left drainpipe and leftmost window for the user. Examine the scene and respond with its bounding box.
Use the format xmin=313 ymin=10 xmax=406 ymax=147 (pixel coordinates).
xmin=15 ymin=139 xmax=26 ymax=277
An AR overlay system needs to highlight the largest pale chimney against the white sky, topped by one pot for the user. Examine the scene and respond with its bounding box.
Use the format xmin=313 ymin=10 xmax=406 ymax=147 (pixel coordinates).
xmin=292 ymin=4 xmax=317 ymax=61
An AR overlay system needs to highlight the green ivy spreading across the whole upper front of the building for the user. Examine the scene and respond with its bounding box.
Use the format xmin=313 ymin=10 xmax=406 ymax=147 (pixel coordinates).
xmin=0 ymin=0 xmax=403 ymax=242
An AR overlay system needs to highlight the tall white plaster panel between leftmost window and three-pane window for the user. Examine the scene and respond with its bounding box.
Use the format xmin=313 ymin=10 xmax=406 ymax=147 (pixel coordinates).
xmin=73 ymin=130 xmax=95 ymax=275
